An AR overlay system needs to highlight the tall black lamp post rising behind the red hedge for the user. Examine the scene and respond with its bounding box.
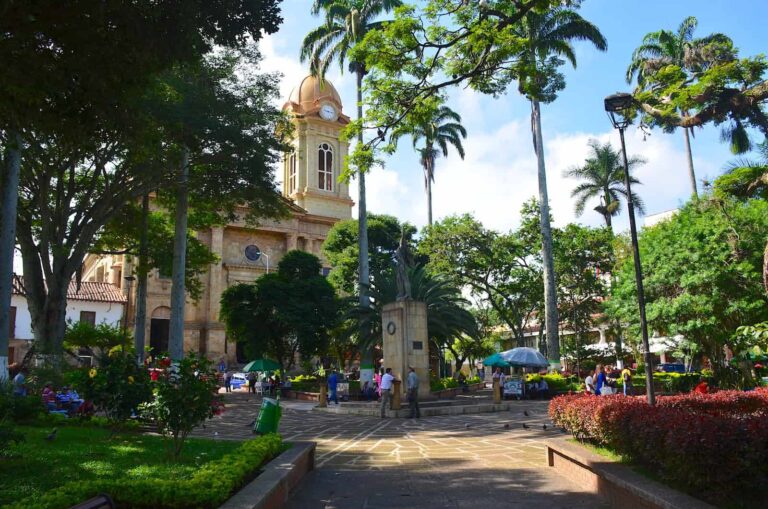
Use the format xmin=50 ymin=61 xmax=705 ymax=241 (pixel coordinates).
xmin=605 ymin=93 xmax=656 ymax=405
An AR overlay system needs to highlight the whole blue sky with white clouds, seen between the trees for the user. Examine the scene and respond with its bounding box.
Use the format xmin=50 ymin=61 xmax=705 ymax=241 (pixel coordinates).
xmin=261 ymin=0 xmax=768 ymax=230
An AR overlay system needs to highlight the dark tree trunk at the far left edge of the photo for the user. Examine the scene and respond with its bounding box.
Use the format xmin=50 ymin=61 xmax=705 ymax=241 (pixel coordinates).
xmin=0 ymin=131 xmax=21 ymax=382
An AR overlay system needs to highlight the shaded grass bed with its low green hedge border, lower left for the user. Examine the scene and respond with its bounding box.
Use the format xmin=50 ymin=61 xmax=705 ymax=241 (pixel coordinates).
xmin=0 ymin=425 xmax=282 ymax=509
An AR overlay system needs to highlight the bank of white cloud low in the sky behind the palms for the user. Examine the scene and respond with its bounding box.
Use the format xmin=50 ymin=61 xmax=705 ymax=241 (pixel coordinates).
xmin=355 ymin=119 xmax=717 ymax=231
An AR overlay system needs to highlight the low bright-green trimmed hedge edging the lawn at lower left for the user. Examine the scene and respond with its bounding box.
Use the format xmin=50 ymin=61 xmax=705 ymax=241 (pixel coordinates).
xmin=2 ymin=434 xmax=283 ymax=509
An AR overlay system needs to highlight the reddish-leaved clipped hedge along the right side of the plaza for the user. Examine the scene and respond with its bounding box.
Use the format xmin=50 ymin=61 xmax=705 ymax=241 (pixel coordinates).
xmin=549 ymin=389 xmax=768 ymax=502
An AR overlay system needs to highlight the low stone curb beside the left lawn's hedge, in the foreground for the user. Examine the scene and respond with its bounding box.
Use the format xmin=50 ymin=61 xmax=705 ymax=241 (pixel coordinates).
xmin=219 ymin=442 xmax=315 ymax=509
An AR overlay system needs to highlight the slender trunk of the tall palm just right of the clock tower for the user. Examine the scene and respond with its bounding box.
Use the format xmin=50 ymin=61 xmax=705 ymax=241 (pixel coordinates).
xmin=356 ymin=66 xmax=373 ymax=383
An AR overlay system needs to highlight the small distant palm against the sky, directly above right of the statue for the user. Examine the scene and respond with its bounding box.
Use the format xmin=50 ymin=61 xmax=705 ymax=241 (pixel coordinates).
xmin=411 ymin=106 xmax=467 ymax=226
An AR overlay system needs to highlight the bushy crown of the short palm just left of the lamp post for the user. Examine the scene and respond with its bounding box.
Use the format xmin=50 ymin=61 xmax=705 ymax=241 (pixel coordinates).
xmin=563 ymin=140 xmax=645 ymax=228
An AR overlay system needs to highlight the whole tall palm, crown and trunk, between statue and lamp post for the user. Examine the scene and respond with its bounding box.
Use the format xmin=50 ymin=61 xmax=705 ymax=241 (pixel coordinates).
xmin=517 ymin=7 xmax=608 ymax=366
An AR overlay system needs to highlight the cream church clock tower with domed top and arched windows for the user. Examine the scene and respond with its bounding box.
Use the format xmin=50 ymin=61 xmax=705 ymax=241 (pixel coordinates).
xmin=283 ymin=76 xmax=353 ymax=219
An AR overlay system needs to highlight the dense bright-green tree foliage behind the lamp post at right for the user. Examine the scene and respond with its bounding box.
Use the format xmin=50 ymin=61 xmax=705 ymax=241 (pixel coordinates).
xmin=607 ymin=197 xmax=768 ymax=369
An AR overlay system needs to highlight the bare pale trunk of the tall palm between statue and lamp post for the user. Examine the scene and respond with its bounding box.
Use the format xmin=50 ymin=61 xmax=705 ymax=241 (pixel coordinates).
xmin=531 ymin=100 xmax=560 ymax=369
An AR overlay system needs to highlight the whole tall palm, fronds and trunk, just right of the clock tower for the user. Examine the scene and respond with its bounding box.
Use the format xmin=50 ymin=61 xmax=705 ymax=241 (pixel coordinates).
xmin=301 ymin=0 xmax=402 ymax=380
